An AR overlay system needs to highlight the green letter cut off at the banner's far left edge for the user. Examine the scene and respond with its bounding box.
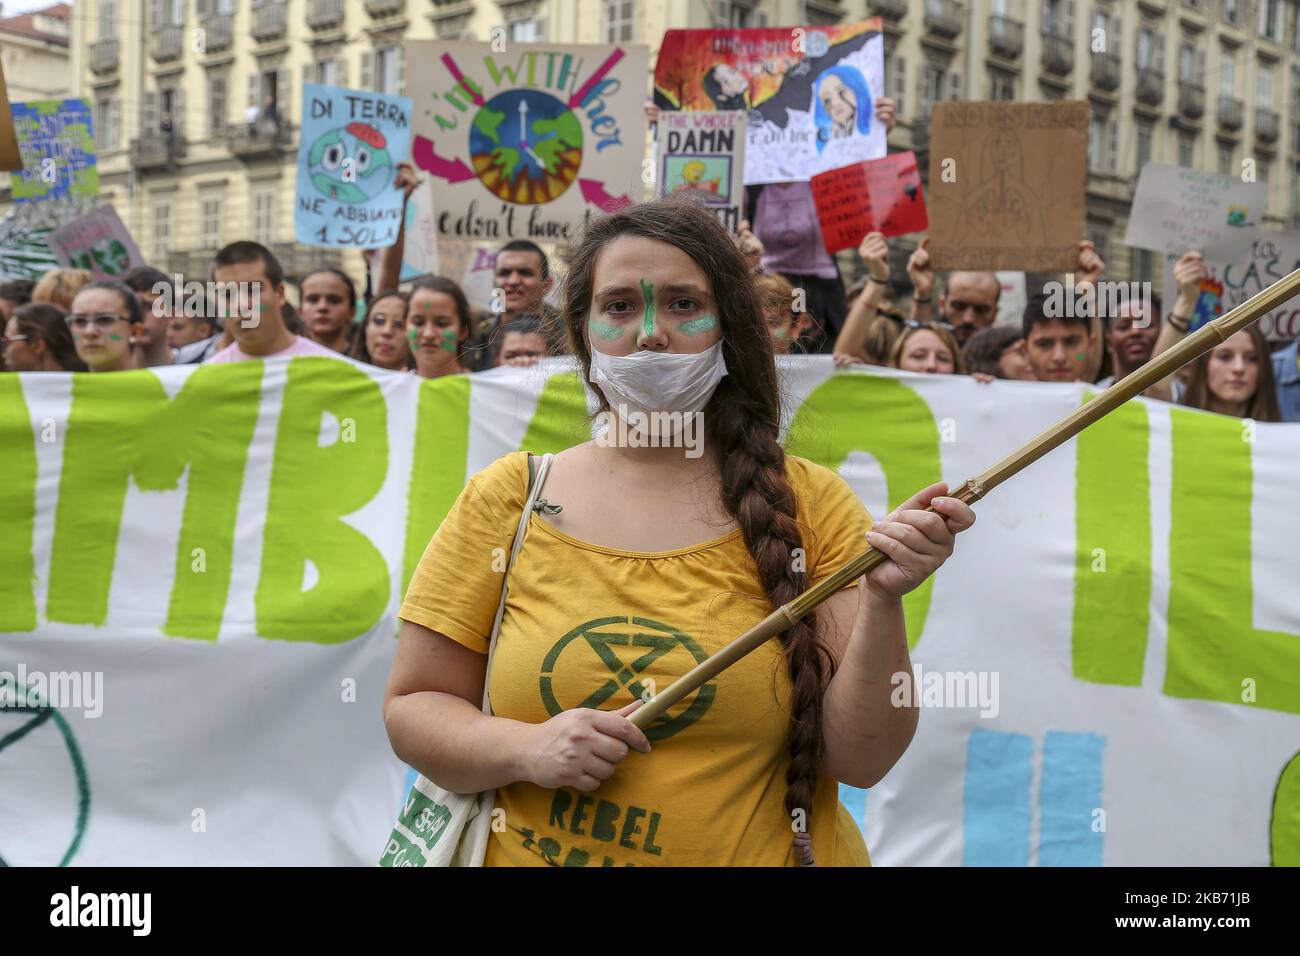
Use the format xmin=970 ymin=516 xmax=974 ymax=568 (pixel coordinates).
xmin=0 ymin=375 xmax=36 ymax=632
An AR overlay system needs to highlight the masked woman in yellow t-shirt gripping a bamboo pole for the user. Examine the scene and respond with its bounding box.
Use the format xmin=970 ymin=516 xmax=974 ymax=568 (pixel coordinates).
xmin=385 ymin=199 xmax=975 ymax=866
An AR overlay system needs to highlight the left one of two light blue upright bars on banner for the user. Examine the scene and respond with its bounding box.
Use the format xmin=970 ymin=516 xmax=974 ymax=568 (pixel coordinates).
xmin=962 ymin=730 xmax=1034 ymax=866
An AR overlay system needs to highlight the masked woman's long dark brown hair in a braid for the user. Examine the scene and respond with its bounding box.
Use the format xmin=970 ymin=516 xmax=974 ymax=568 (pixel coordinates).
xmin=560 ymin=198 xmax=835 ymax=865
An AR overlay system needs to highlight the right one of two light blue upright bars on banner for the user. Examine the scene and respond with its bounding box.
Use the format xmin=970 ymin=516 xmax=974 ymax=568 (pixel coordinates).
xmin=1039 ymin=731 xmax=1106 ymax=866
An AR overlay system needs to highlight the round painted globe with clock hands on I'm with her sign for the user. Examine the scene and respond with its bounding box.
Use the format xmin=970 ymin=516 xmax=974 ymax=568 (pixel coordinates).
xmin=469 ymin=90 xmax=582 ymax=206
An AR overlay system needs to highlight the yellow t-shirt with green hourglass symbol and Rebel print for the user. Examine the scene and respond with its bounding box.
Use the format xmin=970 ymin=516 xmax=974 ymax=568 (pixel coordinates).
xmin=400 ymin=451 xmax=871 ymax=866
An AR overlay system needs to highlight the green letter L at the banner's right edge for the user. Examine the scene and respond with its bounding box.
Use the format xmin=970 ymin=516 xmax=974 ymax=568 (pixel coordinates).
xmin=1165 ymin=408 xmax=1300 ymax=714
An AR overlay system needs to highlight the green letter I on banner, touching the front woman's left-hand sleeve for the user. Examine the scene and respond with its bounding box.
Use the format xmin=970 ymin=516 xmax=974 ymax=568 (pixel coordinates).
xmin=402 ymin=375 xmax=469 ymax=592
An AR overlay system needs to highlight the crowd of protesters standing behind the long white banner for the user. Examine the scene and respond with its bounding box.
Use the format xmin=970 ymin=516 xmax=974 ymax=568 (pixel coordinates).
xmin=0 ymin=98 xmax=1300 ymax=421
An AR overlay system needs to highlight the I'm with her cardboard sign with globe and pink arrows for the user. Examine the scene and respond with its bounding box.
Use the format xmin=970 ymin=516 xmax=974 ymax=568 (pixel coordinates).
xmin=407 ymin=40 xmax=649 ymax=245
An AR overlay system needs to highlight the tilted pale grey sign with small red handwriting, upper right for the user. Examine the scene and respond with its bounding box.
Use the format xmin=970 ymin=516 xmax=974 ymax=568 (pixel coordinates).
xmin=1125 ymin=163 xmax=1269 ymax=258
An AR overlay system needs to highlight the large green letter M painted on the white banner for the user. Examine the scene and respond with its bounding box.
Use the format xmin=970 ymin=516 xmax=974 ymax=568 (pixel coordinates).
xmin=46 ymin=362 xmax=261 ymax=640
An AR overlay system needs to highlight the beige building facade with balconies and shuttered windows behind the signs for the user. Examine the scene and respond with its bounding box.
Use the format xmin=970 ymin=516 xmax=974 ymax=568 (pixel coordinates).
xmin=70 ymin=0 xmax=1300 ymax=291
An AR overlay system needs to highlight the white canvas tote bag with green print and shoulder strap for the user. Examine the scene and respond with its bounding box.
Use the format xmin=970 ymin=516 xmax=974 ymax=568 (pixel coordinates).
xmin=380 ymin=454 xmax=558 ymax=866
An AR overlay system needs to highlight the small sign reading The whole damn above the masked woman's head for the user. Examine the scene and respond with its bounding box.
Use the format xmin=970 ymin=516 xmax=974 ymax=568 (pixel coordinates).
xmin=655 ymin=109 xmax=745 ymax=234
